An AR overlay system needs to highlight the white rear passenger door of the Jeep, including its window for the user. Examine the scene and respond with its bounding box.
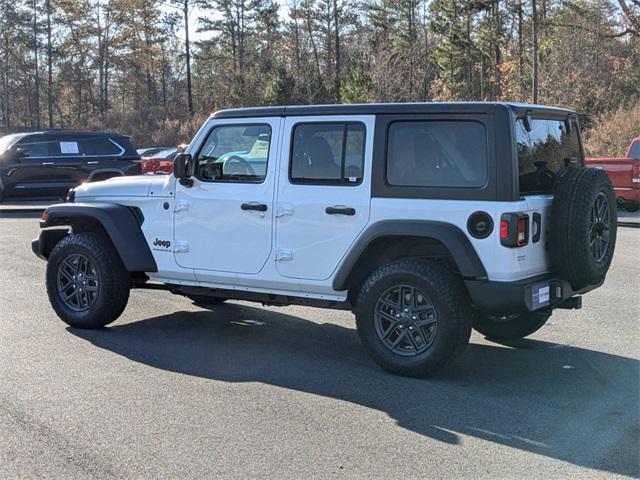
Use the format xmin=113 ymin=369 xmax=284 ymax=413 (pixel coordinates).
xmin=276 ymin=116 xmax=374 ymax=280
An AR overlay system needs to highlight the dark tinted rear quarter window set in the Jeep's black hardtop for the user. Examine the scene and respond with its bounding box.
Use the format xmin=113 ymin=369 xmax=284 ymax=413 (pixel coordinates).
xmin=387 ymin=120 xmax=488 ymax=187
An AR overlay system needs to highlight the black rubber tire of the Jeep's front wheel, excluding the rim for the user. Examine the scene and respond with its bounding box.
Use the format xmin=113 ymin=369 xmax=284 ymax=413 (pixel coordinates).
xmin=46 ymin=232 xmax=130 ymax=329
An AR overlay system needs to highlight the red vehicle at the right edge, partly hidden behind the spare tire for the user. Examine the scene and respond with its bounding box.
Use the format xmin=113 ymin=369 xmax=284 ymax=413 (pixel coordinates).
xmin=585 ymin=136 xmax=640 ymax=212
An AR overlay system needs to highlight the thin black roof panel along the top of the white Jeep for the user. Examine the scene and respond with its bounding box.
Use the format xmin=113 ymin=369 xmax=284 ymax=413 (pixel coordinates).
xmin=211 ymin=102 xmax=575 ymax=119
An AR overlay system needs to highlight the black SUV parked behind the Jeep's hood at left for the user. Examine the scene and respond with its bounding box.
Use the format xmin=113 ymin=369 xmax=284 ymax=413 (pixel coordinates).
xmin=0 ymin=131 xmax=140 ymax=200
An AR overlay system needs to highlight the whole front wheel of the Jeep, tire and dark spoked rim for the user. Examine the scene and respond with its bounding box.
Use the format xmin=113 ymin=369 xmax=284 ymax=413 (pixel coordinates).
xmin=46 ymin=233 xmax=130 ymax=328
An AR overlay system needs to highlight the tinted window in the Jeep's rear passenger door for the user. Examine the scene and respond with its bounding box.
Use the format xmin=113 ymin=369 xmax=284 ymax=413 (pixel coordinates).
xmin=290 ymin=123 xmax=365 ymax=185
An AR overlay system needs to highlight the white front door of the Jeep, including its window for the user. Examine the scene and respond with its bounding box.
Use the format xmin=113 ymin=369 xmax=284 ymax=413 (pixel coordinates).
xmin=172 ymin=117 xmax=282 ymax=282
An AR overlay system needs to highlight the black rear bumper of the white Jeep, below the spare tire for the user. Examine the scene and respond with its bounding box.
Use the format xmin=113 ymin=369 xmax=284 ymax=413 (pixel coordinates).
xmin=465 ymin=274 xmax=602 ymax=316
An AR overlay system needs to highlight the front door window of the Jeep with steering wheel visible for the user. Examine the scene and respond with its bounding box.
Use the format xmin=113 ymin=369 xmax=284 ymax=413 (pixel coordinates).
xmin=196 ymin=125 xmax=271 ymax=183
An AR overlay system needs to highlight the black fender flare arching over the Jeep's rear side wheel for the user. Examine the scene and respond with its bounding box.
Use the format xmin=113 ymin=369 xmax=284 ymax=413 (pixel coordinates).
xmin=333 ymin=220 xmax=487 ymax=292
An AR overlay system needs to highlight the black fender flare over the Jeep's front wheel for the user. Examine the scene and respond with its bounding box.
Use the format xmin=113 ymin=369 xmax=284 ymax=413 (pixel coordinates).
xmin=40 ymin=203 xmax=158 ymax=272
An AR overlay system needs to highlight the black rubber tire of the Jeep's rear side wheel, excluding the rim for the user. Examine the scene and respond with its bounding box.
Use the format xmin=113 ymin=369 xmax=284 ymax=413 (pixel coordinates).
xmin=355 ymin=259 xmax=472 ymax=377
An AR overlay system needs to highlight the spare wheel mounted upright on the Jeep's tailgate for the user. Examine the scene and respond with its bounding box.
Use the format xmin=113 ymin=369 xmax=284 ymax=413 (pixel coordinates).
xmin=549 ymin=167 xmax=618 ymax=290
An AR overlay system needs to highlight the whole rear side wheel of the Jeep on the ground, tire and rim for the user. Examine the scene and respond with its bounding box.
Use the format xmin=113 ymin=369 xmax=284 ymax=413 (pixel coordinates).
xmin=356 ymin=259 xmax=471 ymax=377
